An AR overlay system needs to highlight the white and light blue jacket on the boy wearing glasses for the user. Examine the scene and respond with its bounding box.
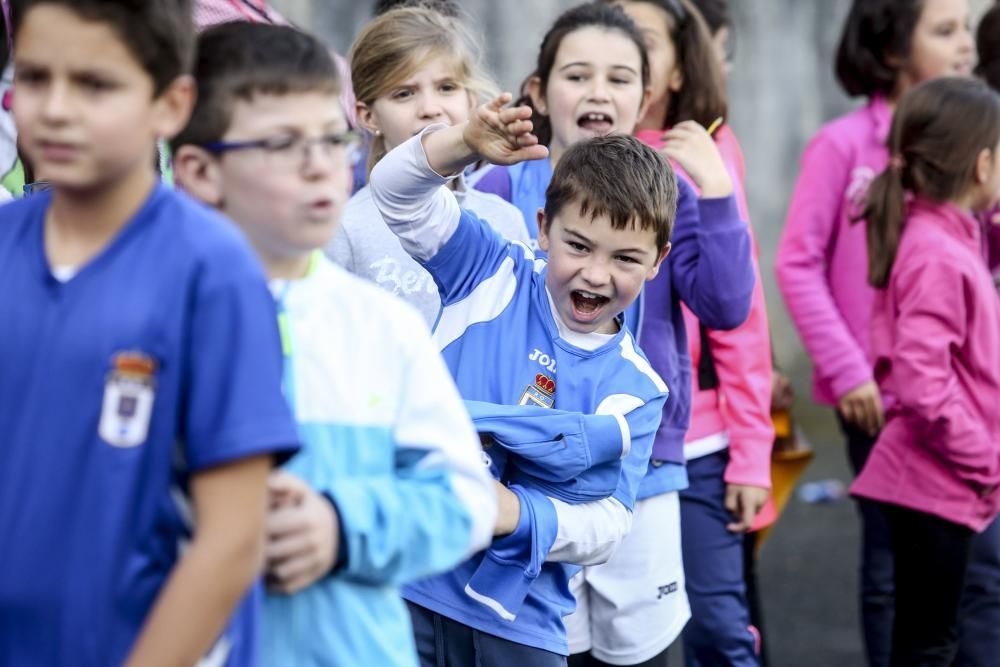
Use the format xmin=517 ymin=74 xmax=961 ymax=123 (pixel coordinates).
xmin=263 ymin=253 xmax=496 ymax=667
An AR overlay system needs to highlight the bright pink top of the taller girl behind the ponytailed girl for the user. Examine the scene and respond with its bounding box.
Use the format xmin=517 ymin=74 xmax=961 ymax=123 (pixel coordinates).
xmin=775 ymin=97 xmax=892 ymax=405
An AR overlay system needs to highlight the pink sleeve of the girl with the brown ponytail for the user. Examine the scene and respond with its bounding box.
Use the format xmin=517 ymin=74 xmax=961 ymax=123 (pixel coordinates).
xmin=890 ymin=260 xmax=997 ymax=485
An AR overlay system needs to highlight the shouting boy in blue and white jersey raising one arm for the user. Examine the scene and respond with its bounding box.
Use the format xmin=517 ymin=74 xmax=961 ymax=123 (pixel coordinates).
xmin=371 ymin=95 xmax=677 ymax=667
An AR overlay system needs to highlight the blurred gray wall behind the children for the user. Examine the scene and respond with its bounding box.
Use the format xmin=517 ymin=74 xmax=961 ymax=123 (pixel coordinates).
xmin=273 ymin=0 xmax=990 ymax=410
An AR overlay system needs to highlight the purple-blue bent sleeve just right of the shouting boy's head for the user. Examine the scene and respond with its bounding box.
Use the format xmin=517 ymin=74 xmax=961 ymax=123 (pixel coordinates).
xmin=668 ymin=178 xmax=754 ymax=330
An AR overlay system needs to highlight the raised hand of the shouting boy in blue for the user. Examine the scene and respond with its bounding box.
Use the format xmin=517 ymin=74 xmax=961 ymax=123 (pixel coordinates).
xmin=462 ymin=93 xmax=549 ymax=164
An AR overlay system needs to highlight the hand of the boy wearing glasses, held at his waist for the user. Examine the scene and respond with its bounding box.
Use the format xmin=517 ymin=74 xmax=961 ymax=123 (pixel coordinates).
xmin=265 ymin=471 xmax=340 ymax=595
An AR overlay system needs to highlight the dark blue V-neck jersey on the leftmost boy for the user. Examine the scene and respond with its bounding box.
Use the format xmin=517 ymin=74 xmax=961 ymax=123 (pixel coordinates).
xmin=0 ymin=186 xmax=298 ymax=667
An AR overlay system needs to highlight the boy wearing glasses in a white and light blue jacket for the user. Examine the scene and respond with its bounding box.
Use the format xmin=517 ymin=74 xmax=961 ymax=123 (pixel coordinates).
xmin=174 ymin=23 xmax=496 ymax=666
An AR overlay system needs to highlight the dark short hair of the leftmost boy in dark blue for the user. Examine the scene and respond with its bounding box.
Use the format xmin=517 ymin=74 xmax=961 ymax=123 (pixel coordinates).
xmin=11 ymin=0 xmax=195 ymax=96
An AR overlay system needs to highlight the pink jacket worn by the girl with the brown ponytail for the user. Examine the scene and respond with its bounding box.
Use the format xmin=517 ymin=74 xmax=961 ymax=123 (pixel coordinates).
xmin=851 ymin=198 xmax=1000 ymax=531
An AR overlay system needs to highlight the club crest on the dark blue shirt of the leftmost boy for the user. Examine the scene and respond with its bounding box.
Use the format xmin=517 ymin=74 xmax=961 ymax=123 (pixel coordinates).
xmin=97 ymin=352 xmax=157 ymax=447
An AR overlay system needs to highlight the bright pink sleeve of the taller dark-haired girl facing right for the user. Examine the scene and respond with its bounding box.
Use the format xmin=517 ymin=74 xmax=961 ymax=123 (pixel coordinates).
xmin=775 ymin=133 xmax=872 ymax=398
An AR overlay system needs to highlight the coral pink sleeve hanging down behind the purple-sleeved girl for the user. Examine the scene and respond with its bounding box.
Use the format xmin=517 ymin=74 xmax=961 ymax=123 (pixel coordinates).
xmin=702 ymin=232 xmax=774 ymax=488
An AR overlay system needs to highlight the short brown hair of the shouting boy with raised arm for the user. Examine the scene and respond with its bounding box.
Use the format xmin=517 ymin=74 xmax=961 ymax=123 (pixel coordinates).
xmin=545 ymin=135 xmax=677 ymax=250
